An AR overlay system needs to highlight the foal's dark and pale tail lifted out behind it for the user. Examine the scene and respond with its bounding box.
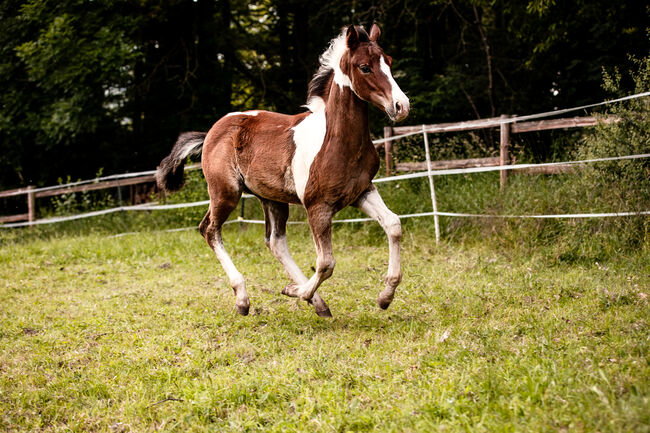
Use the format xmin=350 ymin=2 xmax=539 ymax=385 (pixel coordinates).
xmin=156 ymin=132 xmax=207 ymax=191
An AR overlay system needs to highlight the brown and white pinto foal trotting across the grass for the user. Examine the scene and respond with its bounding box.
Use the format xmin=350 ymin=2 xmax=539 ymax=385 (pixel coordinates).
xmin=156 ymin=24 xmax=409 ymax=316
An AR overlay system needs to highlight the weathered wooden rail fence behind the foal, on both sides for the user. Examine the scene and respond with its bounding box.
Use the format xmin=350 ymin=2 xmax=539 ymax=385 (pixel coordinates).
xmin=0 ymin=115 xmax=616 ymax=224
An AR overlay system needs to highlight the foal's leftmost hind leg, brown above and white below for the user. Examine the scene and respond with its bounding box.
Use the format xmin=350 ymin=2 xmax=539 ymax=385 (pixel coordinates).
xmin=199 ymin=191 xmax=250 ymax=316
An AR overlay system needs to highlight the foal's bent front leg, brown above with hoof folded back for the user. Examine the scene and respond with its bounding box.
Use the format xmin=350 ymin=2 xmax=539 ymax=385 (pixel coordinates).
xmin=282 ymin=204 xmax=336 ymax=301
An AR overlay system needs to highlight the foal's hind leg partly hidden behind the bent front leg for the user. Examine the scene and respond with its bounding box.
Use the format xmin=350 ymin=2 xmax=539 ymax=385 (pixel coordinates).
xmin=260 ymin=199 xmax=332 ymax=317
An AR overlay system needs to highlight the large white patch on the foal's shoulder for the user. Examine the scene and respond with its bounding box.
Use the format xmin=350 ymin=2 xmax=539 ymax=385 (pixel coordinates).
xmin=291 ymin=107 xmax=326 ymax=201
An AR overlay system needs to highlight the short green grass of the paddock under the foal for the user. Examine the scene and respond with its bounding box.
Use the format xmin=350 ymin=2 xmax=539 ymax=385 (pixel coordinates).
xmin=0 ymin=221 xmax=650 ymax=432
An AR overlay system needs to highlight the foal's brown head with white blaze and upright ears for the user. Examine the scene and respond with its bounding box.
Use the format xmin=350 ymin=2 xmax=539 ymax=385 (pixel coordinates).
xmin=334 ymin=24 xmax=410 ymax=122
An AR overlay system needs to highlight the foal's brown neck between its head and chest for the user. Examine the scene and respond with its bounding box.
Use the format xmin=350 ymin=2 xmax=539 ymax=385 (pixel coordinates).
xmin=325 ymin=82 xmax=371 ymax=157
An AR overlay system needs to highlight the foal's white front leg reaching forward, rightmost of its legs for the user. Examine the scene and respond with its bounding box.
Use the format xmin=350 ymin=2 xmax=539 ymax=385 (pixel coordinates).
xmin=354 ymin=185 xmax=402 ymax=310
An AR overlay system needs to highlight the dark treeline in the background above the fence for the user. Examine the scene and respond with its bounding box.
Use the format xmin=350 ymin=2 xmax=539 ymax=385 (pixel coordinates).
xmin=0 ymin=0 xmax=650 ymax=189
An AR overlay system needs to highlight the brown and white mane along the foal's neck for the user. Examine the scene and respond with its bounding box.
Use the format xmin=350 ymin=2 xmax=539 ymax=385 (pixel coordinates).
xmin=305 ymin=26 xmax=370 ymax=112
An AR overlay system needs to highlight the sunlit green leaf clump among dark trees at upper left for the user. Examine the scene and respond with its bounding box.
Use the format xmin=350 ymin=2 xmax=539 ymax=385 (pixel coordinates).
xmin=16 ymin=9 xmax=137 ymax=140
